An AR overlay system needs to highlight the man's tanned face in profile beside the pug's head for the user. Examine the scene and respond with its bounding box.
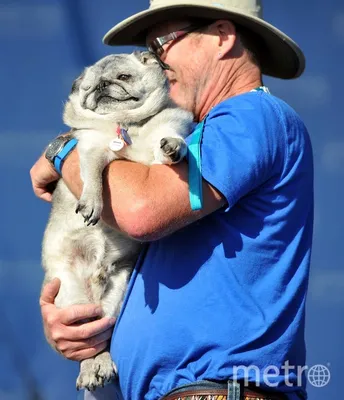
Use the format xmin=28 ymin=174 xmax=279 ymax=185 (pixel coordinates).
xmin=147 ymin=21 xmax=209 ymax=113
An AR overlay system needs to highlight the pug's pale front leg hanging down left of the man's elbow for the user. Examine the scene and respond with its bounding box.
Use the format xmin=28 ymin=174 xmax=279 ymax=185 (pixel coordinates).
xmin=75 ymin=131 xmax=116 ymax=225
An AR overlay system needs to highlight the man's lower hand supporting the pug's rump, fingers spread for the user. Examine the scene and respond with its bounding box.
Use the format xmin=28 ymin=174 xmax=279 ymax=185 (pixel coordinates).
xmin=40 ymin=279 xmax=115 ymax=361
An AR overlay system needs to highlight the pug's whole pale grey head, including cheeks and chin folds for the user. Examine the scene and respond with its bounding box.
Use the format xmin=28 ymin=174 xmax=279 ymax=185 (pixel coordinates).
xmin=64 ymin=52 xmax=169 ymax=128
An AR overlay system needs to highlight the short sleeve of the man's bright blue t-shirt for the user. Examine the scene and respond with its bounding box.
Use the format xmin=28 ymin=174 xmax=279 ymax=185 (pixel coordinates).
xmin=201 ymin=95 xmax=283 ymax=210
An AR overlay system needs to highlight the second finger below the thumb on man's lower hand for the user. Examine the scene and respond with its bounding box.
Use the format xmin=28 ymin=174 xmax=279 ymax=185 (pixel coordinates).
xmin=63 ymin=318 xmax=116 ymax=341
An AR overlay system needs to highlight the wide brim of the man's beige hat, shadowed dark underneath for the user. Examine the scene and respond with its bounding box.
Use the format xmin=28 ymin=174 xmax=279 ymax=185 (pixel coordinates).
xmin=103 ymin=0 xmax=305 ymax=79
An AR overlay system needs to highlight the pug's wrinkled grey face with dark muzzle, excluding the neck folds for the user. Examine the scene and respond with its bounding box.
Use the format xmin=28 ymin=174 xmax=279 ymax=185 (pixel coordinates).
xmin=70 ymin=52 xmax=168 ymax=115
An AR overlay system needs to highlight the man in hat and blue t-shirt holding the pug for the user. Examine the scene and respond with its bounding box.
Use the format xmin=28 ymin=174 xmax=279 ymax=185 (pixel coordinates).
xmin=31 ymin=0 xmax=313 ymax=400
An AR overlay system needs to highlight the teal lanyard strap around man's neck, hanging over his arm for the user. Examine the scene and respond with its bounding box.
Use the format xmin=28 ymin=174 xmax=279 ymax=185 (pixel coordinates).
xmin=188 ymin=86 xmax=270 ymax=211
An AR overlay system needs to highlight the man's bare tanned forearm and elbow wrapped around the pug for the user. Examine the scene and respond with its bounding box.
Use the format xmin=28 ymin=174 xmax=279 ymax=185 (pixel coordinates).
xmin=62 ymin=151 xmax=226 ymax=241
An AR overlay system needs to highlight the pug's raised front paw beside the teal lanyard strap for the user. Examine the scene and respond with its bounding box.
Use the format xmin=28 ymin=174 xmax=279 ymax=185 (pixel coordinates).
xmin=154 ymin=137 xmax=187 ymax=164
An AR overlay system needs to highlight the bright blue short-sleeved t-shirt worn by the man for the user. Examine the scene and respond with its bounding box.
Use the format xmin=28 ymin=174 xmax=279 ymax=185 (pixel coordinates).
xmin=111 ymin=92 xmax=313 ymax=400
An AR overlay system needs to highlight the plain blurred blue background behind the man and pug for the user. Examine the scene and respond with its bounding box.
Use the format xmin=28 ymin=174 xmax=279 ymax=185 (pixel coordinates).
xmin=0 ymin=0 xmax=344 ymax=400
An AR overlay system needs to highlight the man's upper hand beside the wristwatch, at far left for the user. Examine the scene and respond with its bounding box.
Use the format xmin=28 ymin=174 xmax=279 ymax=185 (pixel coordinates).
xmin=30 ymin=154 xmax=60 ymax=202
